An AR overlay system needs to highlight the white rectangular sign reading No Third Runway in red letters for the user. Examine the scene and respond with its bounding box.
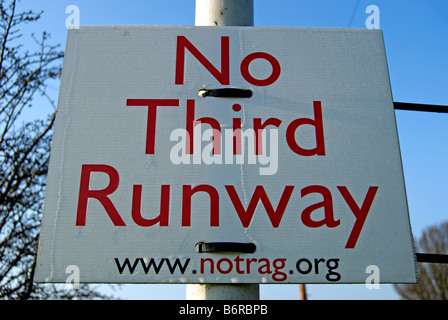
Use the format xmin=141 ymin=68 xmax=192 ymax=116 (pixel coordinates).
xmin=35 ymin=26 xmax=416 ymax=283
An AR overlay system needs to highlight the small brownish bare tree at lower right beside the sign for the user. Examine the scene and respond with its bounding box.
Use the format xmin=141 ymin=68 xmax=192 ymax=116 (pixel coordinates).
xmin=394 ymin=222 xmax=448 ymax=300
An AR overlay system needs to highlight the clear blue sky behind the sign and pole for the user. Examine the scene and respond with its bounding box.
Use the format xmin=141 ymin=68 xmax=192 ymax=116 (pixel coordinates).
xmin=14 ymin=0 xmax=448 ymax=299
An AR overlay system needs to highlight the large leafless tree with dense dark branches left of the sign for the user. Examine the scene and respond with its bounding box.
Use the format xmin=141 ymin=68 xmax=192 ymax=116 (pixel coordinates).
xmin=0 ymin=0 xmax=115 ymax=299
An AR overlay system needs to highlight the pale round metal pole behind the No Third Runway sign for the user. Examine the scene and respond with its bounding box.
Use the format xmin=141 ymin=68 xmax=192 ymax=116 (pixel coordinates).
xmin=186 ymin=0 xmax=260 ymax=300
